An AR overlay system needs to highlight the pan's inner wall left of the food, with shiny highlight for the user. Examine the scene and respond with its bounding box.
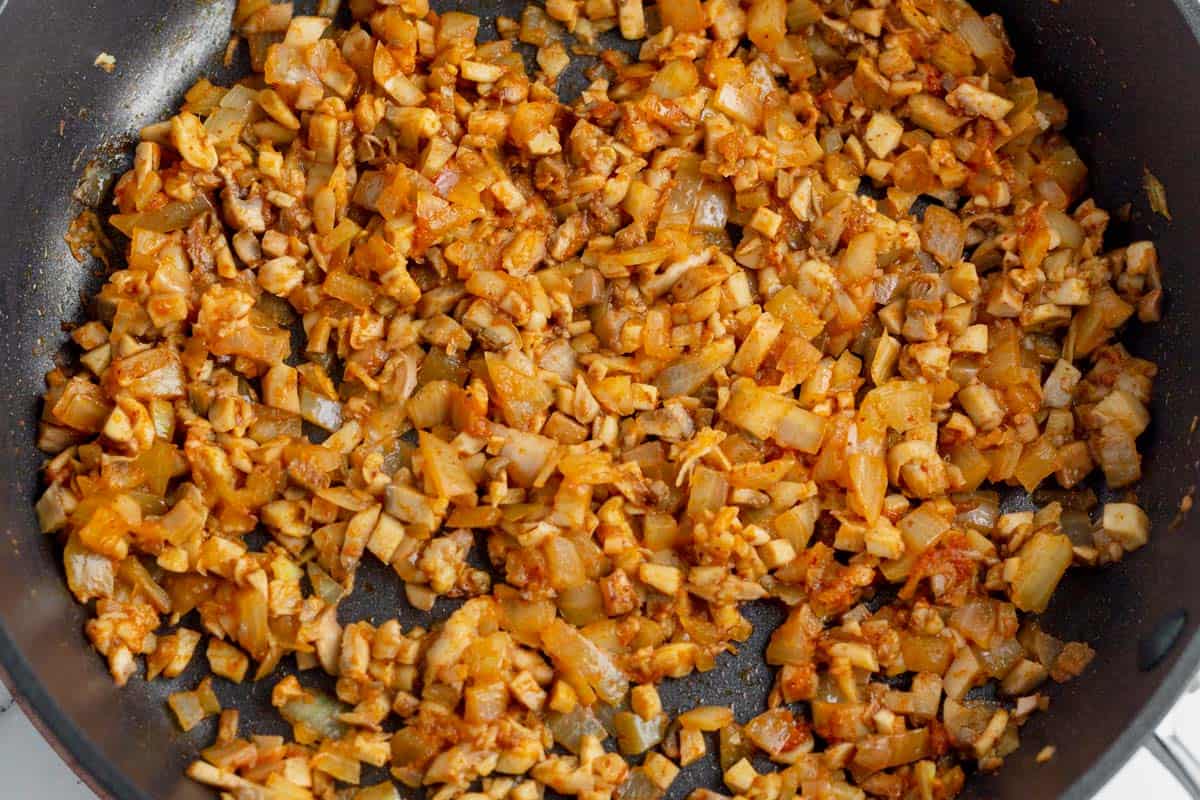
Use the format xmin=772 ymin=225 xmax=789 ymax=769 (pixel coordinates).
xmin=0 ymin=0 xmax=250 ymax=800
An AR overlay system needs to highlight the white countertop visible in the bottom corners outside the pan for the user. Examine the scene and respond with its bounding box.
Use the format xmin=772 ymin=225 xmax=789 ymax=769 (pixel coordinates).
xmin=0 ymin=684 xmax=1200 ymax=800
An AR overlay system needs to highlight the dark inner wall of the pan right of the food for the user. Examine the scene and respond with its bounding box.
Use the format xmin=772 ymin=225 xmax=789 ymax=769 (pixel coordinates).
xmin=976 ymin=0 xmax=1200 ymax=798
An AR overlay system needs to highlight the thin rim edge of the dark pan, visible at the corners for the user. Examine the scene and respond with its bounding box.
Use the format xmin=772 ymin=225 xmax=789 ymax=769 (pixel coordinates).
xmin=0 ymin=0 xmax=1200 ymax=800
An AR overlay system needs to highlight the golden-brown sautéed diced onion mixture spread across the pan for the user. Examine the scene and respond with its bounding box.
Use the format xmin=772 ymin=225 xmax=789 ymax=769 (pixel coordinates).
xmin=37 ymin=0 xmax=1162 ymax=800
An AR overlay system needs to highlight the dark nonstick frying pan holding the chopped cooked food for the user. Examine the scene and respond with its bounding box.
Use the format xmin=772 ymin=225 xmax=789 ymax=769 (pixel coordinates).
xmin=0 ymin=0 xmax=1200 ymax=800
